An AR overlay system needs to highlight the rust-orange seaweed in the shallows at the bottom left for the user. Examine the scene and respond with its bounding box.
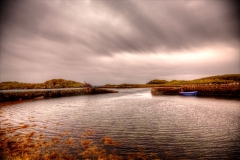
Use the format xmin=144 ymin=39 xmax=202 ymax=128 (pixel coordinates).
xmin=0 ymin=112 xmax=161 ymax=160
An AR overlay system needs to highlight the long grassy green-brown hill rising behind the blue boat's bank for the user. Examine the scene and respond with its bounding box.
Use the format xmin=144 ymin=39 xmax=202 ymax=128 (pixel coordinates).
xmin=103 ymin=74 xmax=240 ymax=88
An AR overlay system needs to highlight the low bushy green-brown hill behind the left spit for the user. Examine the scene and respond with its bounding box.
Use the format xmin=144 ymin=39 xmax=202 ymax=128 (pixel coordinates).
xmin=0 ymin=79 xmax=86 ymax=90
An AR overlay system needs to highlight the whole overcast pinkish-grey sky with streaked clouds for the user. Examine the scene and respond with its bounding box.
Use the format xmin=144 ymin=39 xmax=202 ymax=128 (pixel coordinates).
xmin=0 ymin=0 xmax=240 ymax=85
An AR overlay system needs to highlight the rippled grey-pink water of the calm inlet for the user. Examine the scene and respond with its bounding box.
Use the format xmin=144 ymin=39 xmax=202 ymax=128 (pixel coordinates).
xmin=0 ymin=89 xmax=240 ymax=159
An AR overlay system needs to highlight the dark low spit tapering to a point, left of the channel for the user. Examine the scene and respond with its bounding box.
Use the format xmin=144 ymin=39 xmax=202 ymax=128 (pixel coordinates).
xmin=0 ymin=88 xmax=118 ymax=102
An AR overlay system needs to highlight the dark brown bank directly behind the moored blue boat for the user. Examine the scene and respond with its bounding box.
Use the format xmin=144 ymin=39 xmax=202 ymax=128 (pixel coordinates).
xmin=151 ymin=85 xmax=240 ymax=99
